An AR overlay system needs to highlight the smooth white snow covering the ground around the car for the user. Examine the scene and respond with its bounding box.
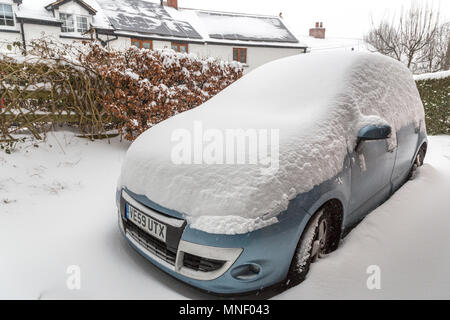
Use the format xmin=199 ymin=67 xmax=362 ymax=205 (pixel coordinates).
xmin=0 ymin=132 xmax=450 ymax=299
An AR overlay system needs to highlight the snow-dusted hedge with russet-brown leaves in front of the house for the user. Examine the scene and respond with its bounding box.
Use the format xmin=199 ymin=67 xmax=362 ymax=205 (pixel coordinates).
xmin=0 ymin=40 xmax=243 ymax=141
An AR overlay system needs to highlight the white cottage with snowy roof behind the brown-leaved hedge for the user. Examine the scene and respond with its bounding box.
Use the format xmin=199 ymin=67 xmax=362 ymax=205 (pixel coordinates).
xmin=0 ymin=0 xmax=307 ymax=70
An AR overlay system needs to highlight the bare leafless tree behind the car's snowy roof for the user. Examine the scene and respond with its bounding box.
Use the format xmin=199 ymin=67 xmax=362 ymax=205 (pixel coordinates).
xmin=364 ymin=1 xmax=449 ymax=73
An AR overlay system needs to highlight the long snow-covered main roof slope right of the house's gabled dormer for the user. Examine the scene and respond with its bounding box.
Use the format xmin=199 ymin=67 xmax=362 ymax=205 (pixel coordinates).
xmin=96 ymin=0 xmax=305 ymax=47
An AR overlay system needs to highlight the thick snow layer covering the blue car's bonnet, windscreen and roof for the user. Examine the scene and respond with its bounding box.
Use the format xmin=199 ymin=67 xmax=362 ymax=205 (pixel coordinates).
xmin=119 ymin=53 xmax=424 ymax=234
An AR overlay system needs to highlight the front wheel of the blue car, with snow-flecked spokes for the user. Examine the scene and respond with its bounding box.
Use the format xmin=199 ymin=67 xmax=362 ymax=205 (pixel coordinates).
xmin=286 ymin=209 xmax=332 ymax=288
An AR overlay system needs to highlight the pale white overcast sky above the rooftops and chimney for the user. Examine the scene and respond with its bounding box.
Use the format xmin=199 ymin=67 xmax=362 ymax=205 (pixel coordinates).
xmin=177 ymin=0 xmax=450 ymax=38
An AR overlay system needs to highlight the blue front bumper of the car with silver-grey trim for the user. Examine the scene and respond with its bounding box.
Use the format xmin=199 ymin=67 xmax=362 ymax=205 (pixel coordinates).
xmin=119 ymin=190 xmax=308 ymax=294
